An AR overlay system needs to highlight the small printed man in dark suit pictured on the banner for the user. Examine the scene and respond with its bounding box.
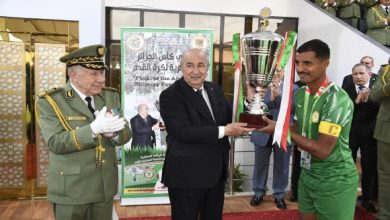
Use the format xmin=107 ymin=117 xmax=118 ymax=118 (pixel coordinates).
xmin=130 ymin=104 xmax=159 ymax=147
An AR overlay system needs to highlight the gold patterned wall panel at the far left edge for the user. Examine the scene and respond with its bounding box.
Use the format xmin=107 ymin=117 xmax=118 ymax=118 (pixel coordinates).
xmin=0 ymin=41 xmax=27 ymax=189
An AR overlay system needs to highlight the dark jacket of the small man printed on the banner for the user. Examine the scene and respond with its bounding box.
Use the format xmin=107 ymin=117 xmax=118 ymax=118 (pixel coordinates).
xmin=130 ymin=114 xmax=157 ymax=147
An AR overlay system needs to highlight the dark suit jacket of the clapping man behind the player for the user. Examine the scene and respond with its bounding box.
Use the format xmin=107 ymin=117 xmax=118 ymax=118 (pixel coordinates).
xmin=343 ymin=74 xmax=379 ymax=137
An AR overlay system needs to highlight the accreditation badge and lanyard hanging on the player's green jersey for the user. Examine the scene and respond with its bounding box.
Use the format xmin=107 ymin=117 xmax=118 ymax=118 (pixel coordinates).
xmin=300 ymin=78 xmax=329 ymax=170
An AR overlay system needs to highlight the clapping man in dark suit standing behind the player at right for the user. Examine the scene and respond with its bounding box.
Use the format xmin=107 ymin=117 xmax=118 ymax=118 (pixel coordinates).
xmin=343 ymin=63 xmax=379 ymax=213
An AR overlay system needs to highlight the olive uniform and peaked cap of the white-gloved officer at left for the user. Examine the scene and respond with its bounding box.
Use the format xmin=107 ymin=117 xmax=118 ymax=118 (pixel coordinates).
xmin=37 ymin=45 xmax=132 ymax=219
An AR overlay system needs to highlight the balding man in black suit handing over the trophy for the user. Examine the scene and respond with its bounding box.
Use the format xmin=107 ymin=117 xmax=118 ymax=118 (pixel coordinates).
xmin=160 ymin=48 xmax=253 ymax=220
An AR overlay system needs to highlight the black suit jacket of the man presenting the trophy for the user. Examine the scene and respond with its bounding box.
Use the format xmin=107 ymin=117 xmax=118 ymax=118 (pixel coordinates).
xmin=160 ymin=78 xmax=232 ymax=189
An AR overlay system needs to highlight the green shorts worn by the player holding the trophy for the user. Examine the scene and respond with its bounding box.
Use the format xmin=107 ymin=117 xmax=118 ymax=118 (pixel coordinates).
xmin=298 ymin=181 xmax=358 ymax=220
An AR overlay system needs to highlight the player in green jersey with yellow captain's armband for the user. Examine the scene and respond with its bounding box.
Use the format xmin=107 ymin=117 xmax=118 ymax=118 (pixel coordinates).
xmin=260 ymin=40 xmax=358 ymax=220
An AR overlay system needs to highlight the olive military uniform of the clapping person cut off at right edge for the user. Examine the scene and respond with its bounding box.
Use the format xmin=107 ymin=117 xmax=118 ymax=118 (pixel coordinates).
xmin=370 ymin=64 xmax=390 ymax=220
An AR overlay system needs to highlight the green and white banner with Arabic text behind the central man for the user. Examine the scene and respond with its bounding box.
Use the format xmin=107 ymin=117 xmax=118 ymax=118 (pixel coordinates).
xmin=121 ymin=27 xmax=213 ymax=204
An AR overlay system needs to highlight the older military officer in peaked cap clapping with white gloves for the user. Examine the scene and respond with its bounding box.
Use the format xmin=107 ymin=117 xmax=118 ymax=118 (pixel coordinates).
xmin=37 ymin=45 xmax=132 ymax=220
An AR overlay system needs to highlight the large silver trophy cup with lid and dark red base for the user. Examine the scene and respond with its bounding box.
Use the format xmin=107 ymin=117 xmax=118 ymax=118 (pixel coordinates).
xmin=239 ymin=8 xmax=284 ymax=128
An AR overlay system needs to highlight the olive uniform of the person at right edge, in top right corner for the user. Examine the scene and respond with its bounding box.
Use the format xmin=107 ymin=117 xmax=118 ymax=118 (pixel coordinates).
xmin=366 ymin=4 xmax=390 ymax=47
